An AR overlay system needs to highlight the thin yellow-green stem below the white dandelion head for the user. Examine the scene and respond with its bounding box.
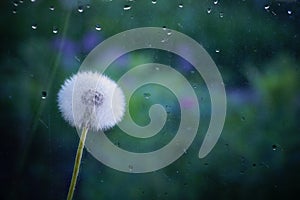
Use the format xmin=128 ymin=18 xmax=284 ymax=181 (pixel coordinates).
xmin=67 ymin=127 xmax=88 ymax=200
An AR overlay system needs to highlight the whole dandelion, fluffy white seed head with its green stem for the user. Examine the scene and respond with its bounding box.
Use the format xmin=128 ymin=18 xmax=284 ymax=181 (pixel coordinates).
xmin=58 ymin=72 xmax=125 ymax=199
